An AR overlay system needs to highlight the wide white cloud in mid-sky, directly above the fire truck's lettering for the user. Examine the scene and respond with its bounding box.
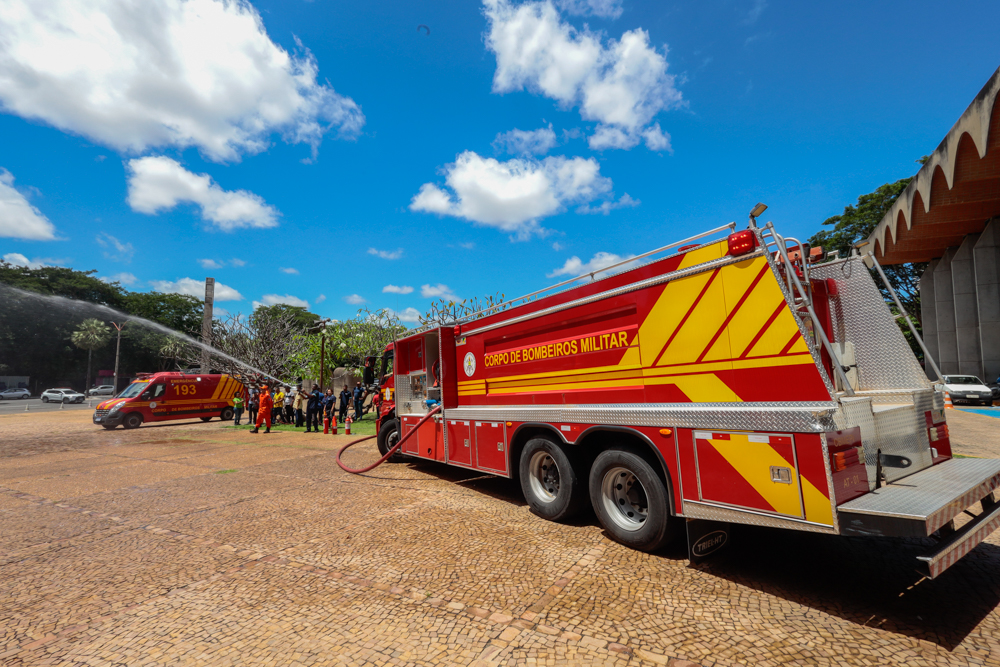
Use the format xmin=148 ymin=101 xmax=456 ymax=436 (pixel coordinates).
xmin=410 ymin=151 xmax=611 ymax=239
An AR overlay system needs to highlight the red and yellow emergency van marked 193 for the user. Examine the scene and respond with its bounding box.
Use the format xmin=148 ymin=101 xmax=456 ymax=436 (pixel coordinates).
xmin=94 ymin=373 xmax=247 ymax=429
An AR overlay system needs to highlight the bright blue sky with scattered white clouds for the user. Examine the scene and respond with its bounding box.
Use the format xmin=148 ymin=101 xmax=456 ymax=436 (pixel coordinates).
xmin=0 ymin=0 xmax=1000 ymax=319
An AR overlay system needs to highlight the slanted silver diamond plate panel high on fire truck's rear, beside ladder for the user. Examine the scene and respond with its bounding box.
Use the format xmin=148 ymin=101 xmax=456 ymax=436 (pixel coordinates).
xmin=810 ymin=257 xmax=929 ymax=390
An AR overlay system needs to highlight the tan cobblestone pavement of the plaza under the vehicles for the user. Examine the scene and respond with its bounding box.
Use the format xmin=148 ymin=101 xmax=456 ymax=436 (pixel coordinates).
xmin=0 ymin=411 xmax=1000 ymax=667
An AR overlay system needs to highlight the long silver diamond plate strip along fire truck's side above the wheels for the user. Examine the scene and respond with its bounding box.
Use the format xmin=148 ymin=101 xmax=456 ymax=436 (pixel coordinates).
xmin=447 ymin=403 xmax=836 ymax=433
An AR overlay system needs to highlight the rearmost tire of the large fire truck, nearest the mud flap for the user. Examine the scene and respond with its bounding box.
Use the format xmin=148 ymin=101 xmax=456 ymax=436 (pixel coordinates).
xmin=590 ymin=449 xmax=677 ymax=551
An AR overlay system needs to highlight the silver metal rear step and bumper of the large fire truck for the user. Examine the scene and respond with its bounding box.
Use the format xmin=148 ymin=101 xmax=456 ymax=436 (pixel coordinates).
xmin=837 ymin=459 xmax=1000 ymax=578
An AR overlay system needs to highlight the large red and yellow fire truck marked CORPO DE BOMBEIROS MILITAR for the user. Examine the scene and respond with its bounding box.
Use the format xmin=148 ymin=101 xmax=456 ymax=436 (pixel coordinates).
xmin=367 ymin=210 xmax=1000 ymax=577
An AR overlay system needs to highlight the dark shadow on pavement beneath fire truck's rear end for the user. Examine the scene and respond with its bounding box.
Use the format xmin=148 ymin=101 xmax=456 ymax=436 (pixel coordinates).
xmin=692 ymin=526 xmax=1000 ymax=651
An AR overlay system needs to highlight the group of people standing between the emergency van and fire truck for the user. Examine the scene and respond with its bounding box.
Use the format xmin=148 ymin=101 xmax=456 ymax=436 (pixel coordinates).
xmin=233 ymin=382 xmax=368 ymax=433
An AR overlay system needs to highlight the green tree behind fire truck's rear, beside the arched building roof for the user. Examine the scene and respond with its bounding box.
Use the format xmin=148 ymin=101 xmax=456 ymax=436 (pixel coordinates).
xmin=809 ymin=162 xmax=927 ymax=359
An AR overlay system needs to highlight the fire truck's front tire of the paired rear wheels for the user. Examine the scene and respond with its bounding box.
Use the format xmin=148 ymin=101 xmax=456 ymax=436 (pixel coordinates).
xmin=518 ymin=438 xmax=587 ymax=521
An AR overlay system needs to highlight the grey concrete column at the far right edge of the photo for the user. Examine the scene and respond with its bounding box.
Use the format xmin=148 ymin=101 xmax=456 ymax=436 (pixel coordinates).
xmin=972 ymin=218 xmax=1000 ymax=382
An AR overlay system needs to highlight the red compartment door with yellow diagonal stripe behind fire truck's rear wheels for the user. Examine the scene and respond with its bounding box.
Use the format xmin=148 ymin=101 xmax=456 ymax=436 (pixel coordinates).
xmin=694 ymin=431 xmax=805 ymax=519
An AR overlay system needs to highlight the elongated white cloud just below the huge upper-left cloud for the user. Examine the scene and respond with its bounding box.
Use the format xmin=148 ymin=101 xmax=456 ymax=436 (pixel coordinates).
xmin=128 ymin=156 xmax=278 ymax=232
